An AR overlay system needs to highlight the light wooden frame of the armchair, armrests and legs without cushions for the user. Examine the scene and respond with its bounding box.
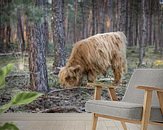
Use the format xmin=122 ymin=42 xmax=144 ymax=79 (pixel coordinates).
xmin=87 ymin=83 xmax=163 ymax=130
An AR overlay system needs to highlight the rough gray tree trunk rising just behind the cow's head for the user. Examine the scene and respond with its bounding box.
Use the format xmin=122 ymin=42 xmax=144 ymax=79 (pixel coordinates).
xmin=52 ymin=0 xmax=66 ymax=70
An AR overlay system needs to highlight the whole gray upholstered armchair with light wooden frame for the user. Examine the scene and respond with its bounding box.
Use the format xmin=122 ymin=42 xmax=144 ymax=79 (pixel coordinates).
xmin=86 ymin=69 xmax=163 ymax=130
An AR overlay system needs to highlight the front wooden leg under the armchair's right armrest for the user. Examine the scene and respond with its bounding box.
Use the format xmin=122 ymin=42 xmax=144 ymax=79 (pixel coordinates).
xmin=141 ymin=90 xmax=152 ymax=130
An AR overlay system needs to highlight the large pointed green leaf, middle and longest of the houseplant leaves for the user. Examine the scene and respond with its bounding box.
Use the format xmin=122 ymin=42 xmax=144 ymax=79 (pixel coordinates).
xmin=0 ymin=91 xmax=43 ymax=113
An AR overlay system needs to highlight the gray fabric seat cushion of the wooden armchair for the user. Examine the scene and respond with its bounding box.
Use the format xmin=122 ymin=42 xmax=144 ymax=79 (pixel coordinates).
xmin=85 ymin=100 xmax=163 ymax=122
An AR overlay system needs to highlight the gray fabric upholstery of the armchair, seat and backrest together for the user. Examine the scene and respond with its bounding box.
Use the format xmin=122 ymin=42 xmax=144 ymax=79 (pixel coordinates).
xmin=85 ymin=69 xmax=163 ymax=122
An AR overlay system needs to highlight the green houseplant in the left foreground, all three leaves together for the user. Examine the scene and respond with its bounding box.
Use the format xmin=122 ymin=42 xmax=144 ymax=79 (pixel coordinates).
xmin=0 ymin=64 xmax=42 ymax=130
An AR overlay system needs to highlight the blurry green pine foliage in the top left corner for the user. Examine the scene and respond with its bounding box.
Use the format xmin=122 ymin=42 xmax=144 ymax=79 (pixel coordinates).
xmin=0 ymin=0 xmax=51 ymax=25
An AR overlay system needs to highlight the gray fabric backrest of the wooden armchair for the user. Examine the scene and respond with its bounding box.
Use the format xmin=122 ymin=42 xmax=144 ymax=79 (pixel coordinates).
xmin=122 ymin=69 xmax=163 ymax=106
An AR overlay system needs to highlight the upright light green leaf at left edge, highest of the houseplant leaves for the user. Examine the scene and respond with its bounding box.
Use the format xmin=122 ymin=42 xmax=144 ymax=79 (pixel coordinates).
xmin=0 ymin=64 xmax=14 ymax=89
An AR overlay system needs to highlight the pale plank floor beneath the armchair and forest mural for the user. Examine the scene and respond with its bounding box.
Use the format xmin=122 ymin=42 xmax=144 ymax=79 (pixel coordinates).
xmin=0 ymin=113 xmax=140 ymax=130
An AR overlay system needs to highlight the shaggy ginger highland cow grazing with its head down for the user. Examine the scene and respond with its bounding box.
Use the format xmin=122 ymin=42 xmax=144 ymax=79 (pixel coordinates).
xmin=59 ymin=32 xmax=127 ymax=87
